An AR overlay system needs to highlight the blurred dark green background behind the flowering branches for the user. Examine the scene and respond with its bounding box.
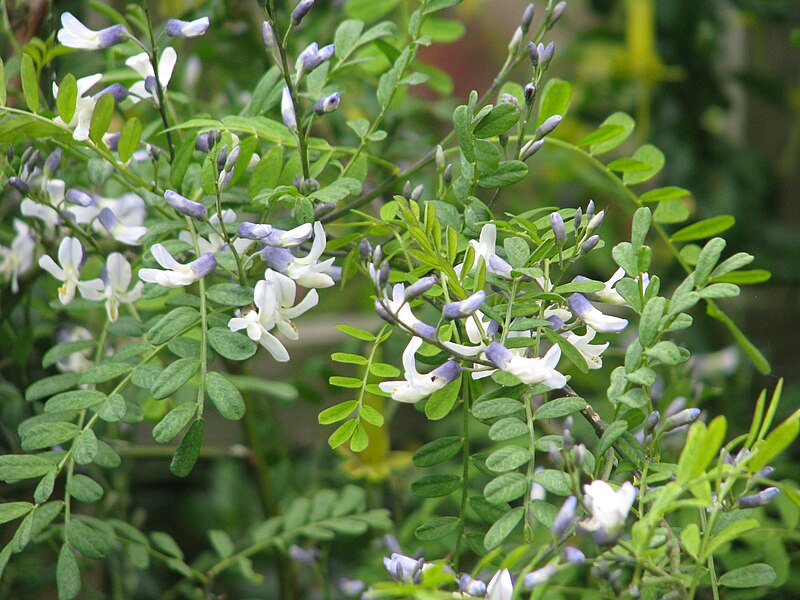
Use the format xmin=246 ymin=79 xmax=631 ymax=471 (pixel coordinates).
xmin=0 ymin=0 xmax=800 ymax=597
